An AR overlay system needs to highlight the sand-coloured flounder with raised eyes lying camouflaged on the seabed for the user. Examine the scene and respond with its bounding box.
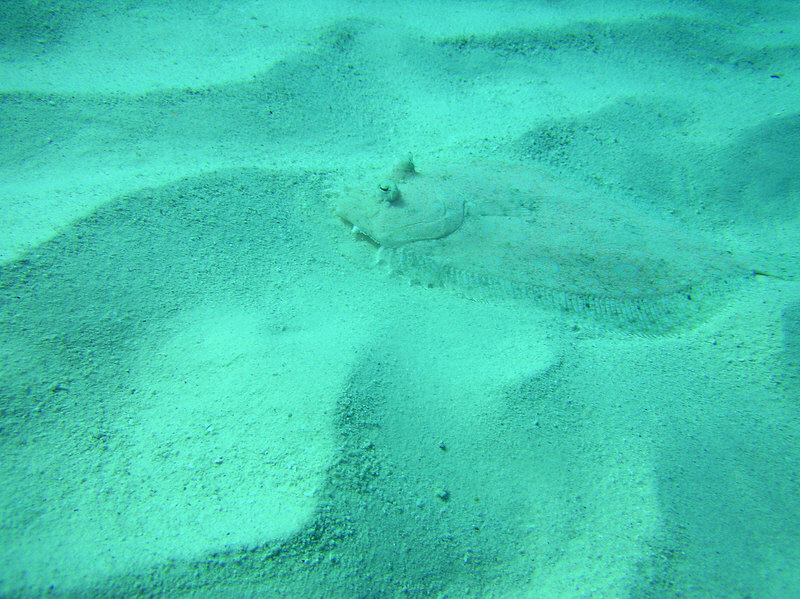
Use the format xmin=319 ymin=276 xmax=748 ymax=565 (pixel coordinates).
xmin=336 ymin=157 xmax=753 ymax=335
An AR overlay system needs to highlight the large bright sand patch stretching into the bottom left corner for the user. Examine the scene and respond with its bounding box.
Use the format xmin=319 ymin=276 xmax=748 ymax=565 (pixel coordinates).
xmin=3 ymin=294 xmax=376 ymax=589
